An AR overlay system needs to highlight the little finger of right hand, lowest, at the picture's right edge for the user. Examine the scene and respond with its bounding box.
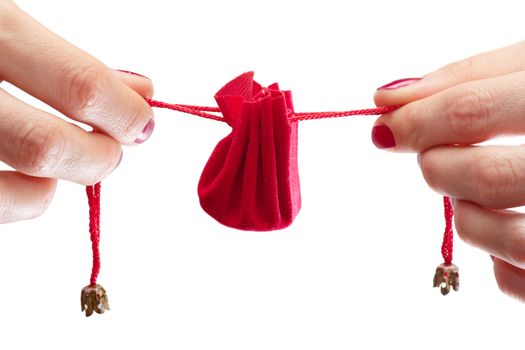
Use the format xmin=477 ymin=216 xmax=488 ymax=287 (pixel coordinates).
xmin=494 ymin=258 xmax=525 ymax=301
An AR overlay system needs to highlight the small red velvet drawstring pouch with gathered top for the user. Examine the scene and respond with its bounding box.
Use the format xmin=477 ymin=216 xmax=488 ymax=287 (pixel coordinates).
xmin=198 ymin=72 xmax=301 ymax=231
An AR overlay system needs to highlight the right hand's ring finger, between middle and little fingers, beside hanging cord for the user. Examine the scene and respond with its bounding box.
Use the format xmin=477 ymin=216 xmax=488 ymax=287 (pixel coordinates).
xmin=454 ymin=200 xmax=525 ymax=268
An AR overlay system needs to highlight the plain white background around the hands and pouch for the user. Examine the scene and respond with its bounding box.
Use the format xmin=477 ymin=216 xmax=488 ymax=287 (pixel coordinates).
xmin=0 ymin=0 xmax=525 ymax=350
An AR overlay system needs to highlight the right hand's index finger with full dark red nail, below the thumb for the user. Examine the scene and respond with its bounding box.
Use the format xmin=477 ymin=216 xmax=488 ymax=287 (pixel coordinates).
xmin=373 ymin=71 xmax=525 ymax=152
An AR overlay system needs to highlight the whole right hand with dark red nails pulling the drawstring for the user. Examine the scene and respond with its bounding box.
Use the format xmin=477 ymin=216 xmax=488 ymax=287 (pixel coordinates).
xmin=372 ymin=42 xmax=525 ymax=300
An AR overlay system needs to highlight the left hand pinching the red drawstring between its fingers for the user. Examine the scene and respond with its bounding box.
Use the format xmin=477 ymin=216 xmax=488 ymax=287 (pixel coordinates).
xmin=0 ymin=0 xmax=154 ymax=223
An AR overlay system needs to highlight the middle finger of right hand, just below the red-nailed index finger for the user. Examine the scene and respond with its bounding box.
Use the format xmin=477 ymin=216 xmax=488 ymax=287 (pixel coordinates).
xmin=419 ymin=146 xmax=525 ymax=209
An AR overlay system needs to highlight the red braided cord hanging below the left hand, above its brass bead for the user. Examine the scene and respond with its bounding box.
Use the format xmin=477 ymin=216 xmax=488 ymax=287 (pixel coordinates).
xmin=86 ymin=182 xmax=100 ymax=286
